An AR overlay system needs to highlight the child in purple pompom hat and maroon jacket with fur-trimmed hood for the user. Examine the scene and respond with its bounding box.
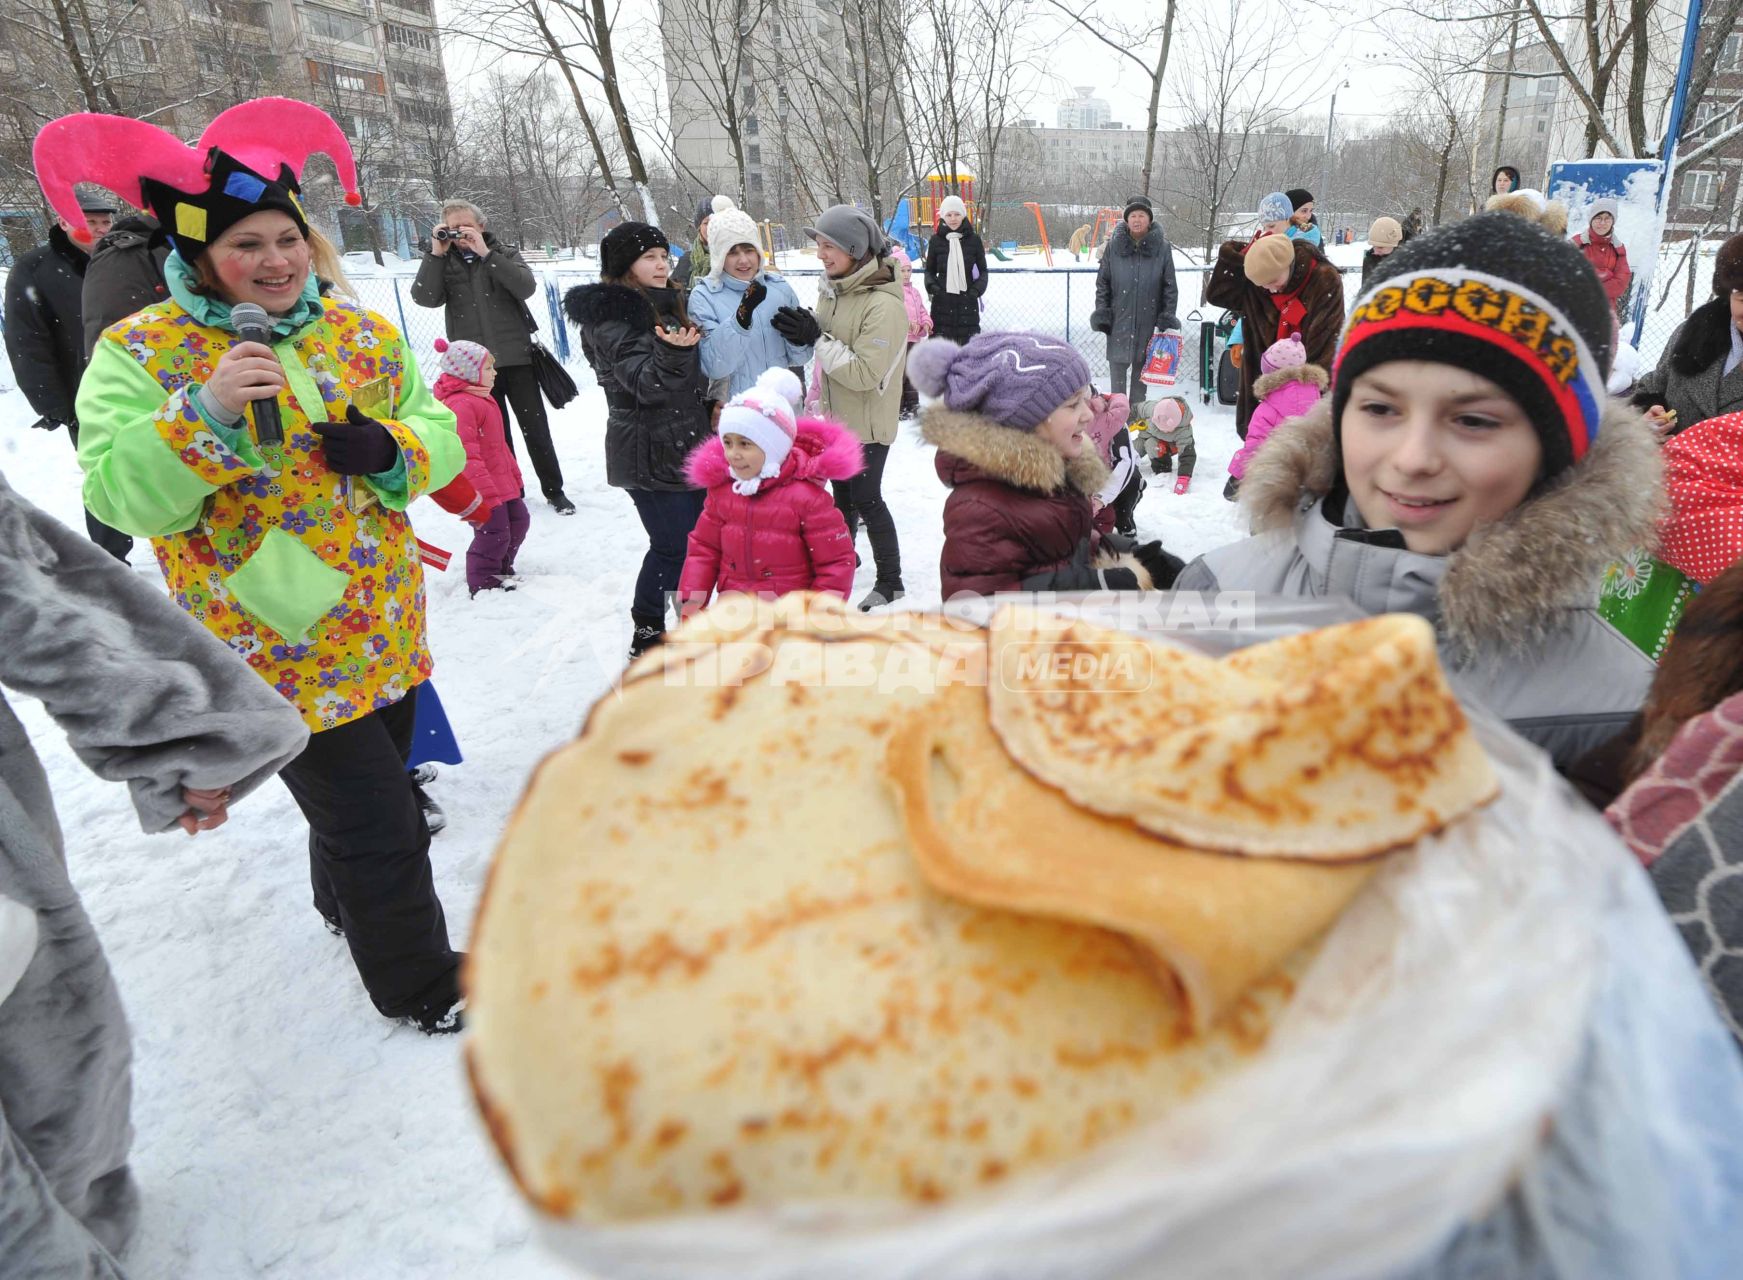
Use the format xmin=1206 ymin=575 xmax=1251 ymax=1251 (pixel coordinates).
xmin=910 ymin=333 xmax=1180 ymax=600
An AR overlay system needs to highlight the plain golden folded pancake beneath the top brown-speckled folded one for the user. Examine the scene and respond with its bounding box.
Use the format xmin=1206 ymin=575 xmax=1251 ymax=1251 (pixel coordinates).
xmin=887 ymin=687 xmax=1382 ymax=1031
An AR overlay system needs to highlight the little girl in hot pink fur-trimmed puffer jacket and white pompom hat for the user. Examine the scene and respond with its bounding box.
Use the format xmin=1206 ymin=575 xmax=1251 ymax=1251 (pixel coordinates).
xmin=678 ymin=368 xmax=863 ymax=617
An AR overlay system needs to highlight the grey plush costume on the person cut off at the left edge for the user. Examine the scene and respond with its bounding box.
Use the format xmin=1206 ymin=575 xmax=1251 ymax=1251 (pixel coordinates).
xmin=0 ymin=478 xmax=309 ymax=1280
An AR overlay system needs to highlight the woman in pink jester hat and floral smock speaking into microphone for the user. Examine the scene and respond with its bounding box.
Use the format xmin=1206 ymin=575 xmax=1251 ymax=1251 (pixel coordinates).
xmin=50 ymin=98 xmax=465 ymax=1034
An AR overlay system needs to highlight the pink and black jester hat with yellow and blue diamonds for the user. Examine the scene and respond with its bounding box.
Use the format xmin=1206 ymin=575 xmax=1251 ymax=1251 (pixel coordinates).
xmin=33 ymin=98 xmax=363 ymax=262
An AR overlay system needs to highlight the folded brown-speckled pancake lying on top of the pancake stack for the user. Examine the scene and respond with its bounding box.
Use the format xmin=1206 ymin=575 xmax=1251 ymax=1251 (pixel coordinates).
xmin=987 ymin=607 xmax=1499 ymax=861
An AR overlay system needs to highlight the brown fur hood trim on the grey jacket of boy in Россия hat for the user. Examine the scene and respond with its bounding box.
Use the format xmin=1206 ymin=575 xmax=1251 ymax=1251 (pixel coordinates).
xmin=1241 ymin=399 xmax=1665 ymax=652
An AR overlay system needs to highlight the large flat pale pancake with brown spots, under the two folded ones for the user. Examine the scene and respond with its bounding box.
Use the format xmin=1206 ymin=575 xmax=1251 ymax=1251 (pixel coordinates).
xmin=465 ymin=628 xmax=1290 ymax=1222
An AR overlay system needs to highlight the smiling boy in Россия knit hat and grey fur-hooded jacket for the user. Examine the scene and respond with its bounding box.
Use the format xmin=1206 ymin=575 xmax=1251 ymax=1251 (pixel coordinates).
xmin=1177 ymin=213 xmax=1663 ymax=767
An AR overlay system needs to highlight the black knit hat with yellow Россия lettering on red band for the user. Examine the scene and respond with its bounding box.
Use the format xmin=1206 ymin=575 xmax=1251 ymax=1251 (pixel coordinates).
xmin=1332 ymin=213 xmax=1614 ymax=480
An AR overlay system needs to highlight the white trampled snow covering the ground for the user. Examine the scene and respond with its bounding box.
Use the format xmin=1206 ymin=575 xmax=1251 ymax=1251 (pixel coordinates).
xmin=0 ymin=366 xmax=1243 ymax=1280
